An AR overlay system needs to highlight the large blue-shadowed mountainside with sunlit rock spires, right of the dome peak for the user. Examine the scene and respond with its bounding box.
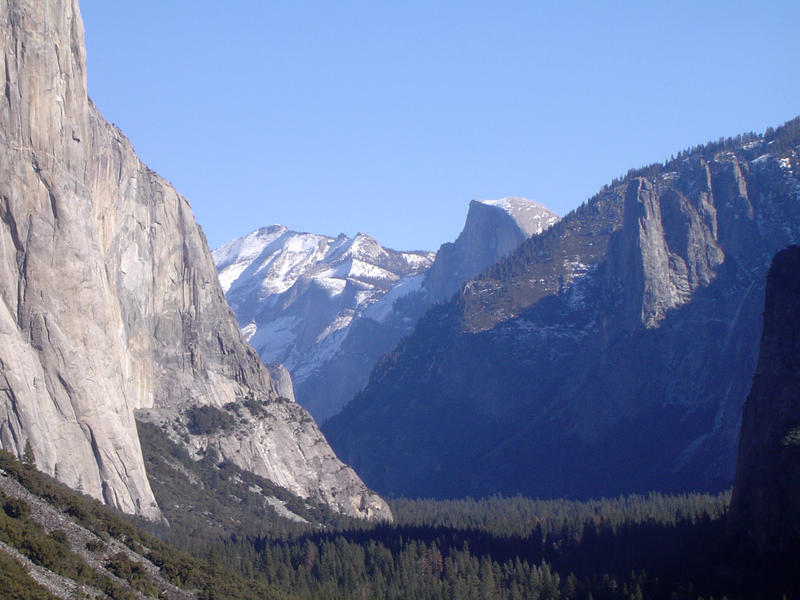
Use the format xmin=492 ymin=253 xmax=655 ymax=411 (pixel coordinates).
xmin=325 ymin=120 xmax=800 ymax=497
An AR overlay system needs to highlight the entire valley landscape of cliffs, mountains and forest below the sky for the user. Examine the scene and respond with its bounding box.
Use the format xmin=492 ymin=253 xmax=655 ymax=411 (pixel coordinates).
xmin=0 ymin=0 xmax=800 ymax=600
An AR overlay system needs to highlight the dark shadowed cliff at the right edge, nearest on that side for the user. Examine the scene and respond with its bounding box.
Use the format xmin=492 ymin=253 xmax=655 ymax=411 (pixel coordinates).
xmin=731 ymin=246 xmax=800 ymax=556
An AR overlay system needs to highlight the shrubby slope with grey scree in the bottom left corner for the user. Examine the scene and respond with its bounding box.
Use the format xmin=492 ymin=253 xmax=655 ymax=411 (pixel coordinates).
xmin=0 ymin=452 xmax=302 ymax=600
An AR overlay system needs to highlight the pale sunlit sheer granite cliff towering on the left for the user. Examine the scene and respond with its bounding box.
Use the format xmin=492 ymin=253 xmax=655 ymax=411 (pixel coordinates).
xmin=0 ymin=0 xmax=389 ymax=518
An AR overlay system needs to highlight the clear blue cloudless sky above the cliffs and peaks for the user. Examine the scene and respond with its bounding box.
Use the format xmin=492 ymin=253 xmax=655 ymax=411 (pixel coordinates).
xmin=81 ymin=0 xmax=800 ymax=250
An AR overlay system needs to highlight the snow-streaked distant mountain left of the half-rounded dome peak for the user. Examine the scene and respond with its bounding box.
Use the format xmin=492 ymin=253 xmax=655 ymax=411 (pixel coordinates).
xmin=213 ymin=225 xmax=434 ymax=420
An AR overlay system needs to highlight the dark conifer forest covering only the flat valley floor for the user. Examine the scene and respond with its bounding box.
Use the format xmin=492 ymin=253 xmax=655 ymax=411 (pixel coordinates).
xmin=216 ymin=493 xmax=796 ymax=600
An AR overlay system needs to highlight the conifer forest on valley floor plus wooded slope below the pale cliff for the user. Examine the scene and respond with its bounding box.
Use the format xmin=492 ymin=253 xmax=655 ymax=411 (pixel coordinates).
xmin=140 ymin=424 xmax=790 ymax=600
